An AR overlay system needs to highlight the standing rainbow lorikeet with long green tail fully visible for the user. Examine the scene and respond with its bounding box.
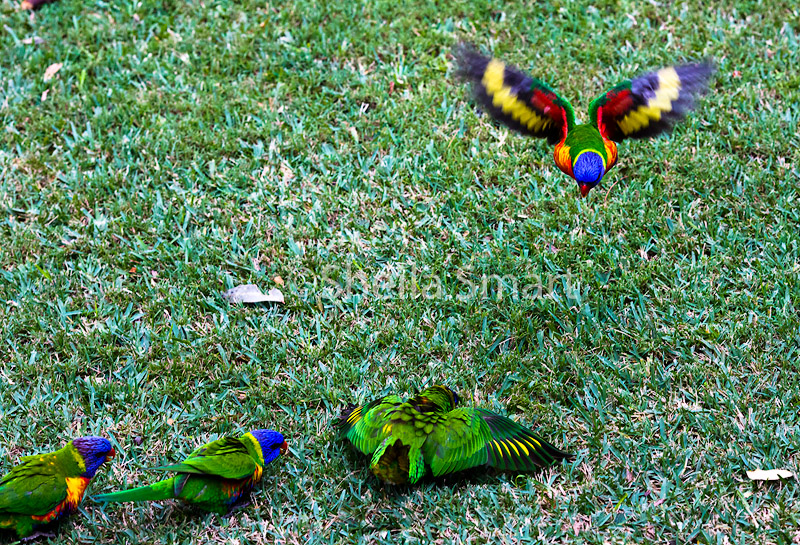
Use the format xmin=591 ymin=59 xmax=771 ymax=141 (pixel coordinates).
xmin=92 ymin=430 xmax=288 ymax=515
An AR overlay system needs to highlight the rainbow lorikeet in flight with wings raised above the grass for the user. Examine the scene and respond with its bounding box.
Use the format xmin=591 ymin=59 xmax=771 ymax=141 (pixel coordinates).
xmin=455 ymin=44 xmax=714 ymax=197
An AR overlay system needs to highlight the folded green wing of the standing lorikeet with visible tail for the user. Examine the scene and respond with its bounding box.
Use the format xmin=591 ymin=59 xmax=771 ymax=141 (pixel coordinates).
xmin=153 ymin=437 xmax=257 ymax=479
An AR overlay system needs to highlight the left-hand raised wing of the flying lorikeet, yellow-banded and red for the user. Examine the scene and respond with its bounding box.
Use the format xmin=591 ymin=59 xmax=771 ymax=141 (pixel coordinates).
xmin=454 ymin=44 xmax=575 ymax=144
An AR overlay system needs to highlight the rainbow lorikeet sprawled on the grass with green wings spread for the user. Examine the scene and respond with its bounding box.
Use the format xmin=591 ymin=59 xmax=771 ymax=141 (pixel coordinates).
xmin=336 ymin=386 xmax=571 ymax=484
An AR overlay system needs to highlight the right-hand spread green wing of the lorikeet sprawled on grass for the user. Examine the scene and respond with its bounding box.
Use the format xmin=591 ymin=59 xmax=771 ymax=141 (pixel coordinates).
xmin=422 ymin=409 xmax=569 ymax=476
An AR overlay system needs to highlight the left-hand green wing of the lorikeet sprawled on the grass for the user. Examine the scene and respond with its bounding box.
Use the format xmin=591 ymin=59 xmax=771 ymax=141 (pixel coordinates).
xmin=335 ymin=395 xmax=403 ymax=454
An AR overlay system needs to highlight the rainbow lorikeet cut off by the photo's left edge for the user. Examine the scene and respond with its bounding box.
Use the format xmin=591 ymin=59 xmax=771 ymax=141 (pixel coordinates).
xmin=0 ymin=437 xmax=116 ymax=538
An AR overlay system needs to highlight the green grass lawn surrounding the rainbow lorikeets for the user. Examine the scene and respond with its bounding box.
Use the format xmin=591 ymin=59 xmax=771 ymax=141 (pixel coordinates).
xmin=0 ymin=0 xmax=800 ymax=544
